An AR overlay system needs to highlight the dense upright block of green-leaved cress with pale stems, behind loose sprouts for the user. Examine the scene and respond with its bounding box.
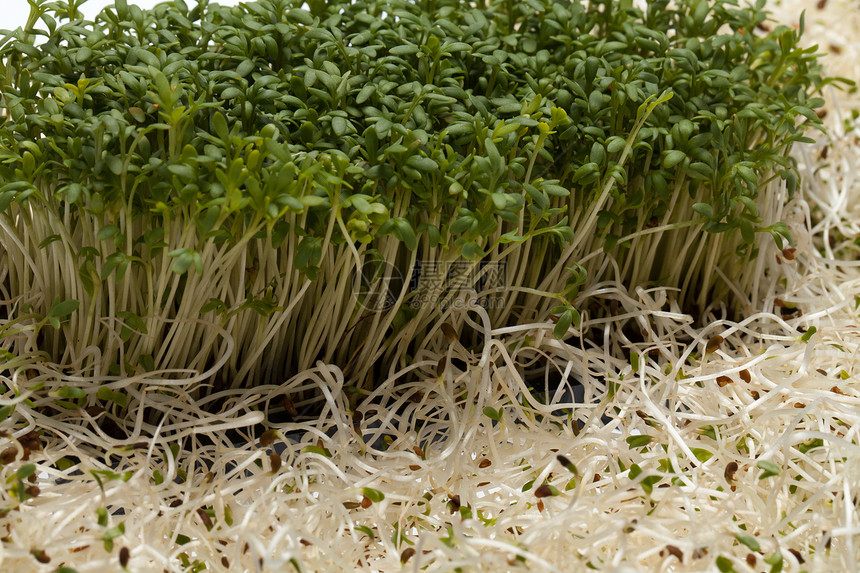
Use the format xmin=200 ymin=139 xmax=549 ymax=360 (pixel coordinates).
xmin=0 ymin=0 xmax=825 ymax=384
